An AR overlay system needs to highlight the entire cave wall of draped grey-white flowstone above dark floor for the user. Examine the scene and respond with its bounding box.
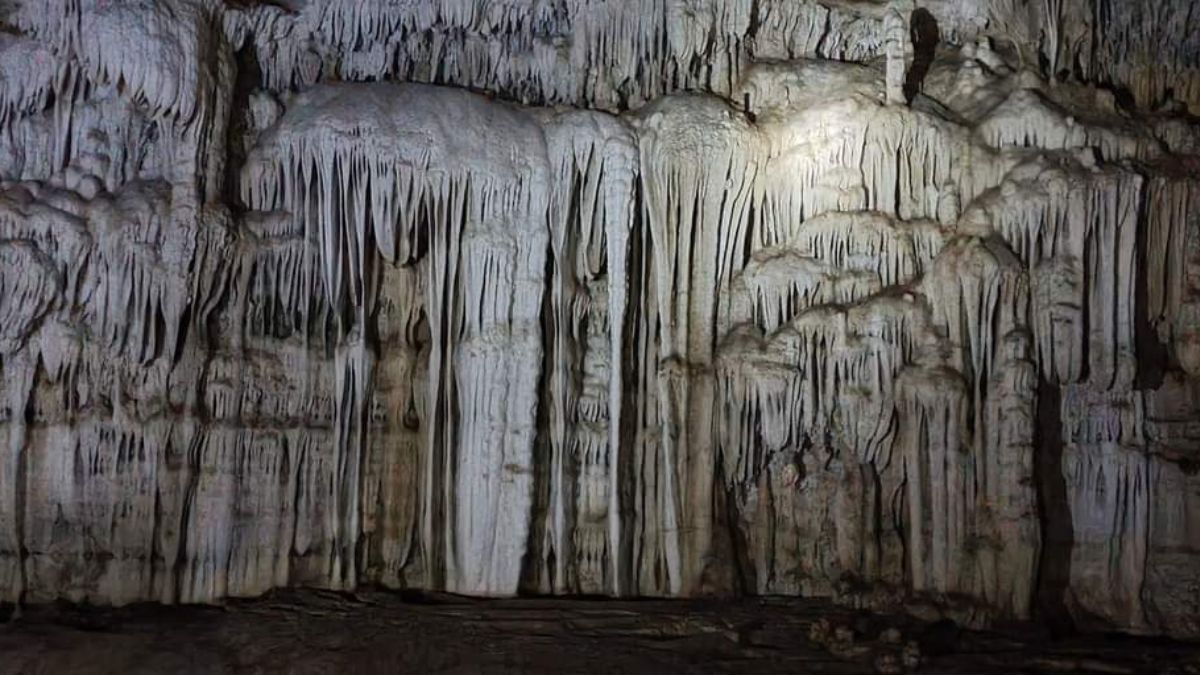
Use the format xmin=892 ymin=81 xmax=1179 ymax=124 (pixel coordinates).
xmin=0 ymin=0 xmax=1200 ymax=638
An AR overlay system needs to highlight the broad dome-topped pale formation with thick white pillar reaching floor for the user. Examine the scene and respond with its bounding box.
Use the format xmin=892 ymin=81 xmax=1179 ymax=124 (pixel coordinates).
xmin=242 ymin=79 xmax=548 ymax=592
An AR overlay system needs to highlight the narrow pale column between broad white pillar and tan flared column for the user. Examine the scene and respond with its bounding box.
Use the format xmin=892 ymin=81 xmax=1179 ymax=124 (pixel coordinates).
xmin=545 ymin=114 xmax=637 ymax=592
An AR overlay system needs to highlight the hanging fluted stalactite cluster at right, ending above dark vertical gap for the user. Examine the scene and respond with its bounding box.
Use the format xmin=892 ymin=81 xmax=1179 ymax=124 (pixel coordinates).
xmin=965 ymin=155 xmax=1142 ymax=388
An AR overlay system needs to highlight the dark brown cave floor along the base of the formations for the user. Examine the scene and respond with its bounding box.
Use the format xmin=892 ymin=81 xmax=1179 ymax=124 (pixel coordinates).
xmin=0 ymin=591 xmax=1200 ymax=675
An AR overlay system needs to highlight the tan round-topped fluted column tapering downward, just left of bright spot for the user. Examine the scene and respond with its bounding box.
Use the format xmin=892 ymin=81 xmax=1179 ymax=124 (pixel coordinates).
xmin=640 ymin=98 xmax=758 ymax=593
